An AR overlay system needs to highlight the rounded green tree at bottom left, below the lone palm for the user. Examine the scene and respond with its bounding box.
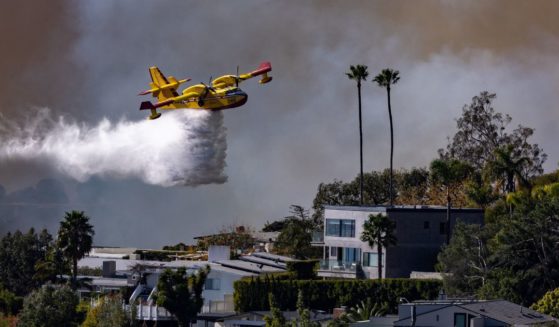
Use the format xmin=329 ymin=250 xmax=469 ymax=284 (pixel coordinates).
xmin=18 ymin=284 xmax=79 ymax=327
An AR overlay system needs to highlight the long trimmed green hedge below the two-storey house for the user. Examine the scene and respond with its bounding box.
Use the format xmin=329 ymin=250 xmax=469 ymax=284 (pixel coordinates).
xmin=234 ymin=276 xmax=442 ymax=313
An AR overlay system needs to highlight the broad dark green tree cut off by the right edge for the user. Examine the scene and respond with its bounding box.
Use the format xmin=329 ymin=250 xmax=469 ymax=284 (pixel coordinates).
xmin=486 ymin=194 xmax=559 ymax=303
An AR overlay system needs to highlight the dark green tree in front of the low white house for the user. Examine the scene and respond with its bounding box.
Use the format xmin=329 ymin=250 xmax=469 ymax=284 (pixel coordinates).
xmin=156 ymin=266 xmax=210 ymax=327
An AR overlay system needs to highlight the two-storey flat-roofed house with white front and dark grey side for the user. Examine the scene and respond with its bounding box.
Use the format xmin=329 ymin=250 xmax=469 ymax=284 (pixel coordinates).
xmin=313 ymin=206 xmax=483 ymax=278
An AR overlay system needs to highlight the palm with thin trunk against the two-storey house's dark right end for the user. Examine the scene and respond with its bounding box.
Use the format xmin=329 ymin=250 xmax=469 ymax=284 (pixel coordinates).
xmin=430 ymin=159 xmax=472 ymax=245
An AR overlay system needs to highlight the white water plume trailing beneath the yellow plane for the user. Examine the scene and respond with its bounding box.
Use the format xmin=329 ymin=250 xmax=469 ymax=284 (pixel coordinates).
xmin=0 ymin=109 xmax=227 ymax=186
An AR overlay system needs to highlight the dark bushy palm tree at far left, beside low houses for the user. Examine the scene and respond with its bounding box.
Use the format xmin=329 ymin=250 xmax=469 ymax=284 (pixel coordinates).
xmin=58 ymin=211 xmax=95 ymax=285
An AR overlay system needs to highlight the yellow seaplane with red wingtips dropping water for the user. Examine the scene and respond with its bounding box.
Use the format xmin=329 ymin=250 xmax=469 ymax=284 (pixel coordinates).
xmin=139 ymin=62 xmax=272 ymax=119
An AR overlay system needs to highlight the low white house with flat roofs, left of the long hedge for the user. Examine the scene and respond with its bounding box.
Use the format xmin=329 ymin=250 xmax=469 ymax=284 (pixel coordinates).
xmin=78 ymin=247 xmax=292 ymax=326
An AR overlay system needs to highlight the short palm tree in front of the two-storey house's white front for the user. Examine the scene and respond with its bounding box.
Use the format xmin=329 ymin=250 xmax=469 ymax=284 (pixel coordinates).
xmin=361 ymin=214 xmax=397 ymax=279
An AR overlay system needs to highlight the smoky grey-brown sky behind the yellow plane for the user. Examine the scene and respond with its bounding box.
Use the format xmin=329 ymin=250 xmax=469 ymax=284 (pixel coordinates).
xmin=0 ymin=0 xmax=559 ymax=247
